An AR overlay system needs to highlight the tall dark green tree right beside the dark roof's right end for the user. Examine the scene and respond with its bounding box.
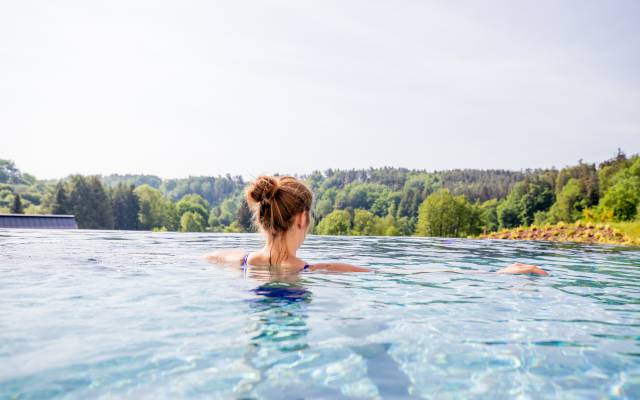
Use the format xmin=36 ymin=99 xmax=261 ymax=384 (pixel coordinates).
xmin=69 ymin=175 xmax=113 ymax=229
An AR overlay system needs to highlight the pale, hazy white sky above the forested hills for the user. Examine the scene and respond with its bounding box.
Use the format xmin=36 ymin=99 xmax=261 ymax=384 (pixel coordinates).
xmin=0 ymin=0 xmax=640 ymax=178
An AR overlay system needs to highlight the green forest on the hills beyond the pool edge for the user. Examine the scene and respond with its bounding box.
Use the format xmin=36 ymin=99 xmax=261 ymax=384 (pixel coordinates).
xmin=0 ymin=150 xmax=640 ymax=237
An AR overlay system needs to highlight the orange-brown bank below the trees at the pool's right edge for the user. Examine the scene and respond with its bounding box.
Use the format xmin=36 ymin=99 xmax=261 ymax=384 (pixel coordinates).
xmin=480 ymin=221 xmax=640 ymax=245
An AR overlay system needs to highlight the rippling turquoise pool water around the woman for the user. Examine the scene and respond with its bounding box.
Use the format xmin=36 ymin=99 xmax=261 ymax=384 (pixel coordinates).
xmin=0 ymin=230 xmax=640 ymax=399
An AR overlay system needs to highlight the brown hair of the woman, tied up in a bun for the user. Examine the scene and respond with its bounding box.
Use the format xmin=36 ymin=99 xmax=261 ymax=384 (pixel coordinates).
xmin=245 ymin=176 xmax=313 ymax=240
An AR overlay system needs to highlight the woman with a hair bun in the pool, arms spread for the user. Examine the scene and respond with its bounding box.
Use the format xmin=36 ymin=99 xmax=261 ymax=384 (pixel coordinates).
xmin=207 ymin=176 xmax=548 ymax=276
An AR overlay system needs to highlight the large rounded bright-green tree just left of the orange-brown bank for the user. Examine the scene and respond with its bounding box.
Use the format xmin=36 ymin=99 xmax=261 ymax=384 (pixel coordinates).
xmin=416 ymin=189 xmax=480 ymax=237
